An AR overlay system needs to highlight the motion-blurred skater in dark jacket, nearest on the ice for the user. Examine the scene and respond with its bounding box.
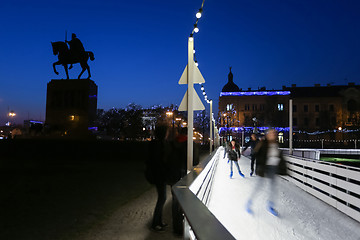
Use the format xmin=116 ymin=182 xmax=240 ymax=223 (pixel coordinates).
xmin=246 ymin=129 xmax=287 ymax=216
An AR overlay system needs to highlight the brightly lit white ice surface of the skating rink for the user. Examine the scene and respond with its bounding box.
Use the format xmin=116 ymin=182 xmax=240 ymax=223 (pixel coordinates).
xmin=209 ymin=148 xmax=360 ymax=240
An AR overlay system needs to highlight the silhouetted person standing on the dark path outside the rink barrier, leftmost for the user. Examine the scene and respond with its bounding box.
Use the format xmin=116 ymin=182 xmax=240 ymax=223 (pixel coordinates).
xmin=145 ymin=125 xmax=168 ymax=232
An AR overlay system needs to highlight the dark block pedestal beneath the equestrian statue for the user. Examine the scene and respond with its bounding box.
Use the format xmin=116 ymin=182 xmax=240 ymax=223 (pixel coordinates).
xmin=46 ymin=79 xmax=98 ymax=136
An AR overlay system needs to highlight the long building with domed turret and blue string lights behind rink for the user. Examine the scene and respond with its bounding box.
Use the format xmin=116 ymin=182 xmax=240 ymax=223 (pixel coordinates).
xmin=219 ymin=69 xmax=360 ymax=139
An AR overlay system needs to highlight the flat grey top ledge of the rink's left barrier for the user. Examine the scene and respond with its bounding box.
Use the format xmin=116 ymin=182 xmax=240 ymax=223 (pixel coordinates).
xmin=172 ymin=149 xmax=235 ymax=240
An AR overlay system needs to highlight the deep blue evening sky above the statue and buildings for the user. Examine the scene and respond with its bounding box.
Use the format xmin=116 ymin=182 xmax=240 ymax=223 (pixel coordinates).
xmin=0 ymin=0 xmax=360 ymax=125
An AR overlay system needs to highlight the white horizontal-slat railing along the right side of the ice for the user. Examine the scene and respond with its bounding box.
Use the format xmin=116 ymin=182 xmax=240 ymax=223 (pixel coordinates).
xmin=285 ymin=156 xmax=360 ymax=222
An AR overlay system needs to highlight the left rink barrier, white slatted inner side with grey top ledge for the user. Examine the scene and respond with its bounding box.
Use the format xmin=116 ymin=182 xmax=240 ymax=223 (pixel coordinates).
xmin=172 ymin=149 xmax=235 ymax=240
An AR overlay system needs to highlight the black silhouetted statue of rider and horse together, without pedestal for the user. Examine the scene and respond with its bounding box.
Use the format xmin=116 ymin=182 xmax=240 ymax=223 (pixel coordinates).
xmin=51 ymin=33 xmax=95 ymax=79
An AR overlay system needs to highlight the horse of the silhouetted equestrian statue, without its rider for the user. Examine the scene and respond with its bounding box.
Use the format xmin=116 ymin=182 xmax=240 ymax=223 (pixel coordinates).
xmin=51 ymin=41 xmax=95 ymax=79
